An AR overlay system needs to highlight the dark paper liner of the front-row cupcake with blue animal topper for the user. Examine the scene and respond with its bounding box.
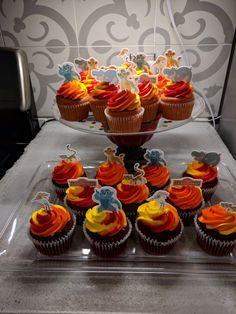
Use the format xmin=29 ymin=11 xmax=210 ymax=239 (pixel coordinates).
xmin=83 ymin=219 xmax=132 ymax=258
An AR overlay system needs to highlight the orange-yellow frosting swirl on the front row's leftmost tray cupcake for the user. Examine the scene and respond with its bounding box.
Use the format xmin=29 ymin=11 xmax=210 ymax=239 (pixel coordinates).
xmin=30 ymin=205 xmax=71 ymax=237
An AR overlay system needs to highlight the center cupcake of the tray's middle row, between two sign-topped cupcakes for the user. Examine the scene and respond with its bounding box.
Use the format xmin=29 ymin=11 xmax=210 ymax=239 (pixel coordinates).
xmin=116 ymin=163 xmax=150 ymax=222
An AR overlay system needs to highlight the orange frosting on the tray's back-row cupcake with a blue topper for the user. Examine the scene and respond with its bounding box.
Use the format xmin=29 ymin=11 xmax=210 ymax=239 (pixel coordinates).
xmin=142 ymin=165 xmax=170 ymax=188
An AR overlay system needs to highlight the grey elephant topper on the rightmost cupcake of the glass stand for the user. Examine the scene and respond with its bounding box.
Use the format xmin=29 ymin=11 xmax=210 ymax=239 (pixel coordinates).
xmin=163 ymin=66 xmax=192 ymax=82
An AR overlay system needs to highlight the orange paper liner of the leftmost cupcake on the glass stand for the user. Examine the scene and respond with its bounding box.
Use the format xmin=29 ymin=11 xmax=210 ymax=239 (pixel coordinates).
xmin=57 ymin=101 xmax=90 ymax=121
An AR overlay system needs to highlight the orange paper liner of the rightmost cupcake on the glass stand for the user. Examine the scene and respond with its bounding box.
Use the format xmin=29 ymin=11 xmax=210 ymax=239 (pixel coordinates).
xmin=159 ymin=100 xmax=194 ymax=120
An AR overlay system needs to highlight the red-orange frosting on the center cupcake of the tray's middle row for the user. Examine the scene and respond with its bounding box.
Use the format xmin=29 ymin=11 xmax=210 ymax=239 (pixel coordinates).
xmin=116 ymin=180 xmax=149 ymax=204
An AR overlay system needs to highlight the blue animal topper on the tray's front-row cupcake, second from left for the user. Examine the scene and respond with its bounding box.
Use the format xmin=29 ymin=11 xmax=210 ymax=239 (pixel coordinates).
xmin=92 ymin=186 xmax=122 ymax=213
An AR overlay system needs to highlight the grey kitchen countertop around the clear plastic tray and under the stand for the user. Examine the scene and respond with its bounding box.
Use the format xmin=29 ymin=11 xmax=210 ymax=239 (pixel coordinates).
xmin=0 ymin=121 xmax=236 ymax=314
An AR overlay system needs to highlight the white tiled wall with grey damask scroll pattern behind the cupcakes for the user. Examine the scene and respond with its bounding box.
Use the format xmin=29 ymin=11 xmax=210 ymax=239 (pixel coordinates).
xmin=0 ymin=0 xmax=236 ymax=117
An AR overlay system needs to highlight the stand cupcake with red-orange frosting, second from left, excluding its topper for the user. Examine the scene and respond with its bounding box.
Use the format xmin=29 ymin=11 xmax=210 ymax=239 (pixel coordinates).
xmin=90 ymin=82 xmax=117 ymax=123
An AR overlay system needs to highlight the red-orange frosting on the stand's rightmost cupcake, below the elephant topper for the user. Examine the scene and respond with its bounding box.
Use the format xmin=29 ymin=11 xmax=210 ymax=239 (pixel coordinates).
xmin=163 ymin=81 xmax=193 ymax=99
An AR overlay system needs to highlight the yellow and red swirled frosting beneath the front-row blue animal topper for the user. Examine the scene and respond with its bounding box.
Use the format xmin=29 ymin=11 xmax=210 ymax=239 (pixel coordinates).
xmin=85 ymin=205 xmax=127 ymax=237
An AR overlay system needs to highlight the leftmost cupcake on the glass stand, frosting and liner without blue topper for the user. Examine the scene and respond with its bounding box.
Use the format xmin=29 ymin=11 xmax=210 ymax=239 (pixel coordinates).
xmin=56 ymin=71 xmax=90 ymax=121
